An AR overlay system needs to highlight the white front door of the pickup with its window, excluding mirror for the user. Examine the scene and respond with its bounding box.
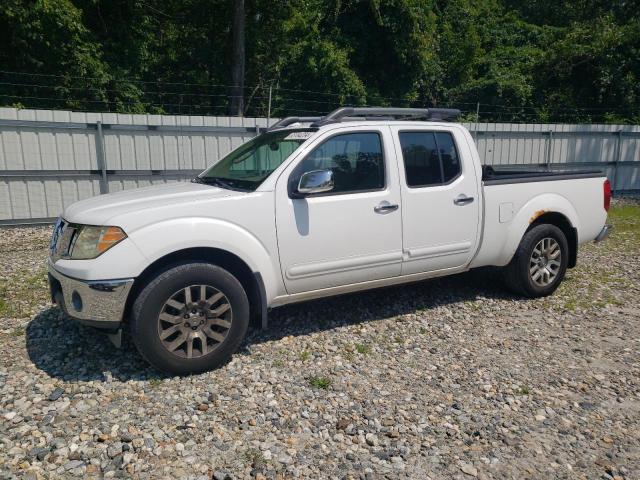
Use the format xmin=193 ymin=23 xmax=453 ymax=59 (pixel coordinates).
xmin=276 ymin=127 xmax=402 ymax=294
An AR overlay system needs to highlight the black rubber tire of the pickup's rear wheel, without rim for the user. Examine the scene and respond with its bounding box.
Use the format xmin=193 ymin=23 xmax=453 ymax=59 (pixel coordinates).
xmin=503 ymin=223 xmax=569 ymax=298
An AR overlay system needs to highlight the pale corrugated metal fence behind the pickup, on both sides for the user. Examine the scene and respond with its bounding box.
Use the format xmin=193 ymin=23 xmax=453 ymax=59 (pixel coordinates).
xmin=0 ymin=108 xmax=640 ymax=225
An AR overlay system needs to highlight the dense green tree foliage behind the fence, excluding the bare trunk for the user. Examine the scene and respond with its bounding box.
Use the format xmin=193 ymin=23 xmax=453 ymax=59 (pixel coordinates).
xmin=0 ymin=0 xmax=640 ymax=123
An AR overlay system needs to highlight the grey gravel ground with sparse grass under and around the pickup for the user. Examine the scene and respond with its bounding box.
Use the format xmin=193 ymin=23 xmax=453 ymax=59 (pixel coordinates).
xmin=0 ymin=203 xmax=640 ymax=479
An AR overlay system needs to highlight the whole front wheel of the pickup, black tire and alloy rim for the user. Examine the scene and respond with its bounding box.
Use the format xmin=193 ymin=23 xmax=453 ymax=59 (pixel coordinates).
xmin=131 ymin=263 xmax=249 ymax=375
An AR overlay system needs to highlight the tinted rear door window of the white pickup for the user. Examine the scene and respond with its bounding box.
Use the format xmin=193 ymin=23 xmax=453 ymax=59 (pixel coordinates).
xmin=399 ymin=132 xmax=461 ymax=188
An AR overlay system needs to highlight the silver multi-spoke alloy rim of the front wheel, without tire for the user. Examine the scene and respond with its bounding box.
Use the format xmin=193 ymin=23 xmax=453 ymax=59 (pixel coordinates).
xmin=158 ymin=285 xmax=233 ymax=358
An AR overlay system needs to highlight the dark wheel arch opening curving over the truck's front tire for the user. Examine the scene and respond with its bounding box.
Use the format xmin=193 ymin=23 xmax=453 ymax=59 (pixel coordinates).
xmin=123 ymin=247 xmax=267 ymax=327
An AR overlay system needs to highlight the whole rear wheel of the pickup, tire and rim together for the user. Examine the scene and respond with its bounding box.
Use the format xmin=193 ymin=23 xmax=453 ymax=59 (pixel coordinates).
xmin=504 ymin=224 xmax=569 ymax=298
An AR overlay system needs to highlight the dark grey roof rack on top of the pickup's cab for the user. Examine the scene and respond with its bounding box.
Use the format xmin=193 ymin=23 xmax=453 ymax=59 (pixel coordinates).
xmin=267 ymin=107 xmax=461 ymax=131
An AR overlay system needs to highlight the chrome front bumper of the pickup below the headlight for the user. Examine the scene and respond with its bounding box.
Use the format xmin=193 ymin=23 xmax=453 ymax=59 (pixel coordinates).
xmin=48 ymin=261 xmax=133 ymax=330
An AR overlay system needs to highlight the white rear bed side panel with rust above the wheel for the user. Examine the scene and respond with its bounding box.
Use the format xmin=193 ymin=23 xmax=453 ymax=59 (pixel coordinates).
xmin=470 ymin=176 xmax=607 ymax=268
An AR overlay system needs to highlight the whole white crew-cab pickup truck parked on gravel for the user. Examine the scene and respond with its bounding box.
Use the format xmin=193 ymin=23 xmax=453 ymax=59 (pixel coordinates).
xmin=49 ymin=108 xmax=611 ymax=374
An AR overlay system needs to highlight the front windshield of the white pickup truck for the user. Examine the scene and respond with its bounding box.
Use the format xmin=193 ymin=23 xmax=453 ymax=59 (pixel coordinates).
xmin=194 ymin=129 xmax=315 ymax=192
